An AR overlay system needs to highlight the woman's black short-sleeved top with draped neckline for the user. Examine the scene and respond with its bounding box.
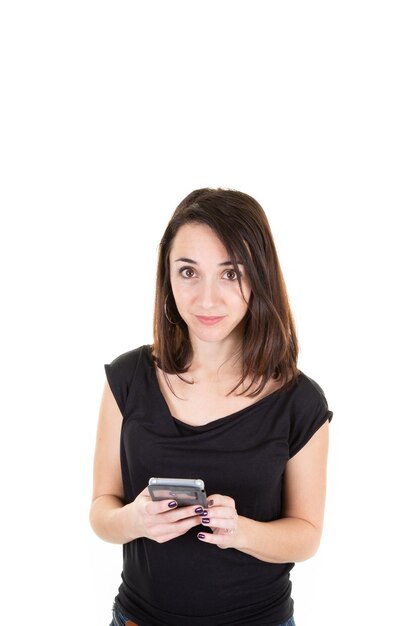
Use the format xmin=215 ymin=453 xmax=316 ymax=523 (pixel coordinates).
xmin=104 ymin=345 xmax=333 ymax=626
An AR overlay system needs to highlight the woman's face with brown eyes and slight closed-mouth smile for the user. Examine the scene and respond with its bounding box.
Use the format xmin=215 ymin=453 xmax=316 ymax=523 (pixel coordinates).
xmin=169 ymin=224 xmax=251 ymax=342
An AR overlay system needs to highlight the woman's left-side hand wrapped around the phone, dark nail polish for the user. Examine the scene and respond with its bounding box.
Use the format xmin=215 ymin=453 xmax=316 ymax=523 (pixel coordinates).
xmin=124 ymin=487 xmax=204 ymax=543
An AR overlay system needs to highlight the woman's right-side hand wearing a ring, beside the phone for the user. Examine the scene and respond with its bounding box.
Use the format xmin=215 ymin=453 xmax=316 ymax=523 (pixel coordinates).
xmin=197 ymin=493 xmax=239 ymax=548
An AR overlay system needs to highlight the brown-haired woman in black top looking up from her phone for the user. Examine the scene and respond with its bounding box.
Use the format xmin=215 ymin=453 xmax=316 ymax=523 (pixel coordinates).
xmin=90 ymin=189 xmax=332 ymax=626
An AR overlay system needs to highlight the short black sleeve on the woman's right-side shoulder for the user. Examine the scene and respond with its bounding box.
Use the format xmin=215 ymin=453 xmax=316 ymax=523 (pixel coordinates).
xmin=289 ymin=374 xmax=333 ymax=458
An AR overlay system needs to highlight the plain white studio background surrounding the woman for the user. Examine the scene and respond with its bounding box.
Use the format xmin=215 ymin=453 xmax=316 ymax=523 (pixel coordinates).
xmin=0 ymin=0 xmax=417 ymax=626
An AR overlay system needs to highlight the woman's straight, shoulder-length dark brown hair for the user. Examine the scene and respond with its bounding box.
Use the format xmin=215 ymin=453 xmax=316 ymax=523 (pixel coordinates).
xmin=152 ymin=188 xmax=298 ymax=397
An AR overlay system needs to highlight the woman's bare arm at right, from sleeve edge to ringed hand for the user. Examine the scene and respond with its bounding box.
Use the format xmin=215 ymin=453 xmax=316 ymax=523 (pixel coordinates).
xmin=198 ymin=422 xmax=329 ymax=563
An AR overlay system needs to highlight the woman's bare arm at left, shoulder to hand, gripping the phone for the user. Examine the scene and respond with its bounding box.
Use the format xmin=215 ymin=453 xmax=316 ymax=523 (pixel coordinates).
xmin=90 ymin=380 xmax=200 ymax=543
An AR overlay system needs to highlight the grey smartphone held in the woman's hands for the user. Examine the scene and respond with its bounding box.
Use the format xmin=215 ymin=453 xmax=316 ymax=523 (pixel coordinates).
xmin=148 ymin=478 xmax=207 ymax=508
